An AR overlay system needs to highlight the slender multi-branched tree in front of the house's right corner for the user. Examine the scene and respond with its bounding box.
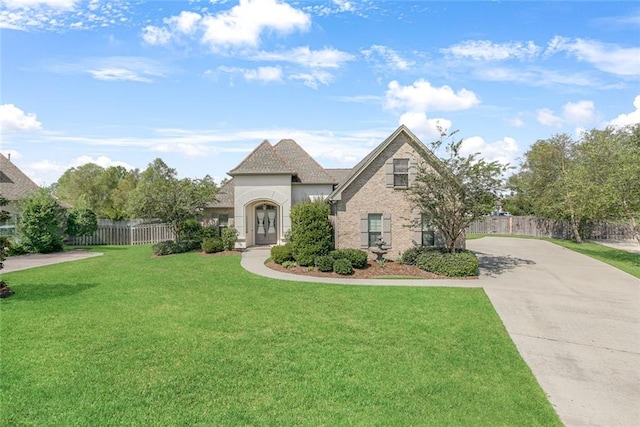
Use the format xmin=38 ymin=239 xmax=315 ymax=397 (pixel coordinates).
xmin=407 ymin=131 xmax=508 ymax=252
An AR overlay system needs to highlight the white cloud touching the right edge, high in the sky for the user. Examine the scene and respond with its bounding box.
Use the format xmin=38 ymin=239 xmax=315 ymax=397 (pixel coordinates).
xmin=545 ymin=36 xmax=640 ymax=76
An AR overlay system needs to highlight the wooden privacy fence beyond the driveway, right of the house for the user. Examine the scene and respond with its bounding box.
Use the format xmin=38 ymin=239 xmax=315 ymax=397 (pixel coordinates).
xmin=466 ymin=216 xmax=634 ymax=240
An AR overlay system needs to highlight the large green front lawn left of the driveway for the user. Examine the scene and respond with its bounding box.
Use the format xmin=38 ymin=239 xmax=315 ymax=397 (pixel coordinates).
xmin=0 ymin=247 xmax=561 ymax=426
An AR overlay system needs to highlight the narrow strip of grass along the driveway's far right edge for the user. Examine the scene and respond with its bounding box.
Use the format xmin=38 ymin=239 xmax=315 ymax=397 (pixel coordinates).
xmin=467 ymin=234 xmax=640 ymax=279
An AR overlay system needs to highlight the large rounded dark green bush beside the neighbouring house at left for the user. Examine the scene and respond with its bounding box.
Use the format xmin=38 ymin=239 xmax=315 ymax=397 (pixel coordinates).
xmin=18 ymin=189 xmax=66 ymax=253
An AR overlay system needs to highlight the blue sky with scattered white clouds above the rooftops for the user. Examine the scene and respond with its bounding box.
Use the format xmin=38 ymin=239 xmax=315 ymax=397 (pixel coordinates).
xmin=0 ymin=0 xmax=640 ymax=185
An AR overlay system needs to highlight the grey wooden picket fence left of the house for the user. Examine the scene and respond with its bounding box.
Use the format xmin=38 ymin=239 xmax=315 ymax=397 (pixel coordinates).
xmin=67 ymin=220 xmax=175 ymax=245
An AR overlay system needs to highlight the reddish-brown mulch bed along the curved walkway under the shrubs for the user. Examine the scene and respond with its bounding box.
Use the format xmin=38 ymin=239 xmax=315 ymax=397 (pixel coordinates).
xmin=265 ymin=260 xmax=464 ymax=279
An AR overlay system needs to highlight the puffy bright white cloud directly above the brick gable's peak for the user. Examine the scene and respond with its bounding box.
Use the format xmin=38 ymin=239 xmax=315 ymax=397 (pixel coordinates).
xmin=385 ymin=80 xmax=480 ymax=112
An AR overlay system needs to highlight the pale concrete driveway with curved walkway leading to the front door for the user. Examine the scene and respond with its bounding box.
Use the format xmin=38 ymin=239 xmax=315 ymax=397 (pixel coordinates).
xmin=242 ymin=237 xmax=640 ymax=426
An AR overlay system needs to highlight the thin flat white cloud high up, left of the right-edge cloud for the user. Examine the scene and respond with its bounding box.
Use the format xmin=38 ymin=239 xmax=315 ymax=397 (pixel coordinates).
xmin=440 ymin=40 xmax=542 ymax=61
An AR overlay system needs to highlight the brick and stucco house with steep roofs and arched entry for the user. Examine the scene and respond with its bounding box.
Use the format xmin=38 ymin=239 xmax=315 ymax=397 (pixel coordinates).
xmin=205 ymin=125 xmax=464 ymax=258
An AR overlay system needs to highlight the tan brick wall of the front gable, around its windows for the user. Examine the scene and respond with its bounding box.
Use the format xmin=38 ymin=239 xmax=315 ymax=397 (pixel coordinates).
xmin=334 ymin=134 xmax=421 ymax=259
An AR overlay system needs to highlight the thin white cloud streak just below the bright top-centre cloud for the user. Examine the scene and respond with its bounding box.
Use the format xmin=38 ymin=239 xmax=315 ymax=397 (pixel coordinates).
xmin=251 ymin=46 xmax=354 ymax=68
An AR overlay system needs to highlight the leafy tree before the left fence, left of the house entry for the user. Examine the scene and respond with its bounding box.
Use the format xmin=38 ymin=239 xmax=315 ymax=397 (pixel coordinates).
xmin=129 ymin=158 xmax=218 ymax=239
